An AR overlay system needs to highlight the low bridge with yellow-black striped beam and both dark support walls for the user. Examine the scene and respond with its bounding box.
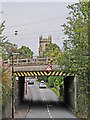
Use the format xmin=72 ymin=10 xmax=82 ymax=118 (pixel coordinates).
xmin=3 ymin=56 xmax=78 ymax=117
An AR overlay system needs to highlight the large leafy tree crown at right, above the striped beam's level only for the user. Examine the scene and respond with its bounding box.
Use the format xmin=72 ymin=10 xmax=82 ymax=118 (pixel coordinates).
xmin=59 ymin=2 xmax=88 ymax=74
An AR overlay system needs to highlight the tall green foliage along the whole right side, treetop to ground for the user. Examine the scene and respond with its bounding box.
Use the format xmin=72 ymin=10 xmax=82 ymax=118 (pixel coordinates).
xmin=58 ymin=2 xmax=90 ymax=118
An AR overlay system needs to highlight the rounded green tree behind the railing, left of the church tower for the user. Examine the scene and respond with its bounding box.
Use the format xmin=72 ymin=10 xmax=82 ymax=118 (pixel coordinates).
xmin=18 ymin=46 xmax=34 ymax=57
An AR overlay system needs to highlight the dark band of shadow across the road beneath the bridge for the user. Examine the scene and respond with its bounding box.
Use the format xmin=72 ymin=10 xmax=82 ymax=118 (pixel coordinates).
xmin=19 ymin=99 xmax=70 ymax=111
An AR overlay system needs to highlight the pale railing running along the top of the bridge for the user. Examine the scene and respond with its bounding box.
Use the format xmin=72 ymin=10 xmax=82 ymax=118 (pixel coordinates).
xmin=3 ymin=56 xmax=57 ymax=66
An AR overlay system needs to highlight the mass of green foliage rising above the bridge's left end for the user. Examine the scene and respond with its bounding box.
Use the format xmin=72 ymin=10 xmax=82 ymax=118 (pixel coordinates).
xmin=0 ymin=22 xmax=33 ymax=60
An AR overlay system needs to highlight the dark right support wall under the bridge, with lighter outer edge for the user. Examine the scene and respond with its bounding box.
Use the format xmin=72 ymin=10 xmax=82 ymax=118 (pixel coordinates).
xmin=64 ymin=76 xmax=77 ymax=109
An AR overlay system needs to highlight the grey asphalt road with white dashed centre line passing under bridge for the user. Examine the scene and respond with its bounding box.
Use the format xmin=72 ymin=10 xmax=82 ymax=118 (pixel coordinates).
xmin=26 ymin=81 xmax=76 ymax=120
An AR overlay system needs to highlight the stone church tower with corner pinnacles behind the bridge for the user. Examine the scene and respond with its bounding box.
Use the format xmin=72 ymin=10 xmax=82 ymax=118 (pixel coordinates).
xmin=39 ymin=36 xmax=52 ymax=56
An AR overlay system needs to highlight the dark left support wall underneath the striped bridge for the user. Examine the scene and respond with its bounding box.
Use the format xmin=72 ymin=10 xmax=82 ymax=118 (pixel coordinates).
xmin=19 ymin=77 xmax=25 ymax=103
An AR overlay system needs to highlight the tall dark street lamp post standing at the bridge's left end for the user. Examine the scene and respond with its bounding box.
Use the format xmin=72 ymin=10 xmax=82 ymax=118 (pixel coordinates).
xmin=11 ymin=53 xmax=20 ymax=118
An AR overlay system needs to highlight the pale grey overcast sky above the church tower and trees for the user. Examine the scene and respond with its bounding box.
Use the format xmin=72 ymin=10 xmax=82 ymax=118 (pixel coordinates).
xmin=0 ymin=0 xmax=79 ymax=56
